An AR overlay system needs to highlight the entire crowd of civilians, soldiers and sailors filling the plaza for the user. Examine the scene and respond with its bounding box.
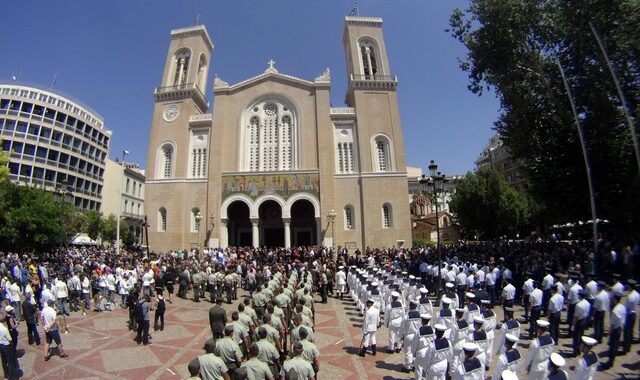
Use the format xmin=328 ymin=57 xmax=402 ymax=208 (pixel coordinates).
xmin=0 ymin=242 xmax=640 ymax=379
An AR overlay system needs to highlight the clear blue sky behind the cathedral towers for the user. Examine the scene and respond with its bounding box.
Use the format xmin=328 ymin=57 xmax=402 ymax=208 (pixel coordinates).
xmin=0 ymin=0 xmax=499 ymax=174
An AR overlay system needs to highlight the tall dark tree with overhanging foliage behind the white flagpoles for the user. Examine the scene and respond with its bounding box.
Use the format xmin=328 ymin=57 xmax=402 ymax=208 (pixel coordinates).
xmin=450 ymin=0 xmax=640 ymax=236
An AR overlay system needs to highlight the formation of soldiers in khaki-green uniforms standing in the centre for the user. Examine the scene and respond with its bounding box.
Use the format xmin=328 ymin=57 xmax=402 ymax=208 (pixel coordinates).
xmin=189 ymin=266 xmax=326 ymax=379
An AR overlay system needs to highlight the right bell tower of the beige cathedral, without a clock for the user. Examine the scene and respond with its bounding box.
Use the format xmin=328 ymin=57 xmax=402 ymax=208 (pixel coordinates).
xmin=343 ymin=16 xmax=411 ymax=247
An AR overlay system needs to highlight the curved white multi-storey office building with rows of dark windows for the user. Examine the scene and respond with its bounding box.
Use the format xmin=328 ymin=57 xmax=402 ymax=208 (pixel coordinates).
xmin=0 ymin=81 xmax=111 ymax=210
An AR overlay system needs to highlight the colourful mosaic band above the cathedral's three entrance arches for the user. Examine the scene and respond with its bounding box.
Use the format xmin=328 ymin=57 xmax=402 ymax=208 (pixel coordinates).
xmin=222 ymin=173 xmax=320 ymax=200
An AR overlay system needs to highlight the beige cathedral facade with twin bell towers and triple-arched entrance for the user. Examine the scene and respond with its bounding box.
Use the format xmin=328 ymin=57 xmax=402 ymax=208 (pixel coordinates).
xmin=145 ymin=16 xmax=411 ymax=251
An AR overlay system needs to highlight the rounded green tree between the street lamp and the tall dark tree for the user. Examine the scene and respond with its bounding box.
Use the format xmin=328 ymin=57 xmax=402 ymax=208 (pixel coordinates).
xmin=450 ymin=169 xmax=530 ymax=239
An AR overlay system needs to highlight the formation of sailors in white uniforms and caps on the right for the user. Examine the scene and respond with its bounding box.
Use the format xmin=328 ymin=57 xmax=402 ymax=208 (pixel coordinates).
xmin=336 ymin=260 xmax=640 ymax=380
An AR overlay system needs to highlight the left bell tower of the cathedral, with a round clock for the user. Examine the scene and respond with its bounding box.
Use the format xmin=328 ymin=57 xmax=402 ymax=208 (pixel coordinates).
xmin=145 ymin=25 xmax=213 ymax=248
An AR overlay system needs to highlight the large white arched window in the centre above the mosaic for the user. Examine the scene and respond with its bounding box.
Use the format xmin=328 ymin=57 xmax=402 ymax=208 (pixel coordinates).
xmin=240 ymin=99 xmax=297 ymax=172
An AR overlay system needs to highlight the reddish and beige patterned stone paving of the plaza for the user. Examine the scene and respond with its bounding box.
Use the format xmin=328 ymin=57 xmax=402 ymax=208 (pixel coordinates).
xmin=6 ymin=292 xmax=640 ymax=380
